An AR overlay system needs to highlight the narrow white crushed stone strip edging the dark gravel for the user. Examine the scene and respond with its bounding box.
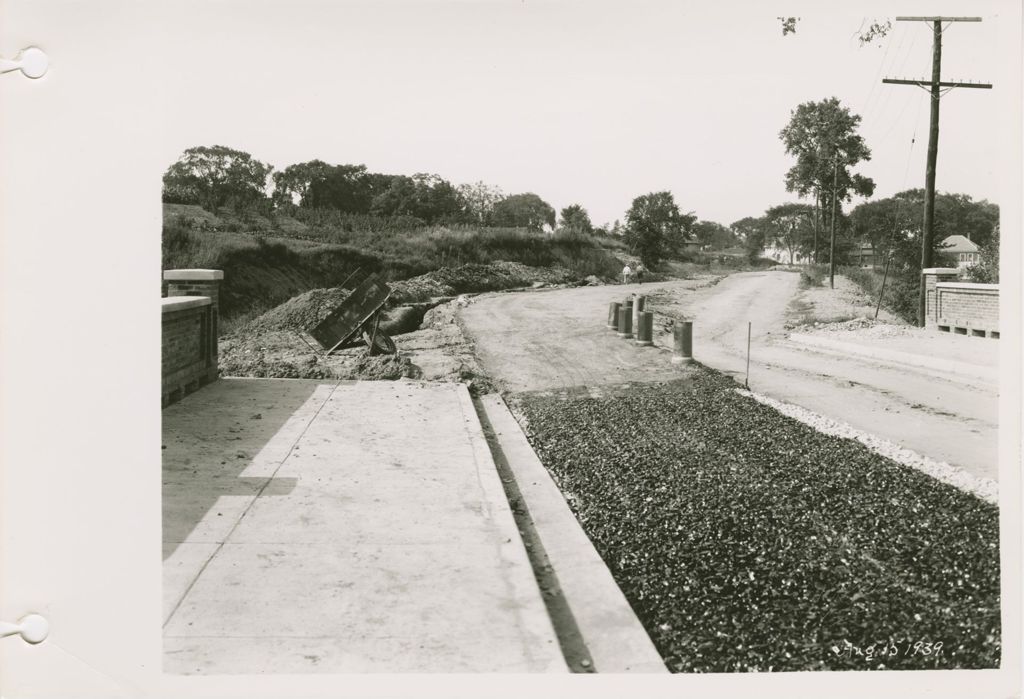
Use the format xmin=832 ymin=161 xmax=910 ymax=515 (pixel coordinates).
xmin=735 ymin=388 xmax=999 ymax=505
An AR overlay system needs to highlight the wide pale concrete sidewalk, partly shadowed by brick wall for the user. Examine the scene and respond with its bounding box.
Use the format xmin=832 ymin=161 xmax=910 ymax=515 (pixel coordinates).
xmin=164 ymin=379 xmax=566 ymax=673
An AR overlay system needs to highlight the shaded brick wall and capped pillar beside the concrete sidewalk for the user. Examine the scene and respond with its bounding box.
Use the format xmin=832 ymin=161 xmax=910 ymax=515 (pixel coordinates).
xmin=161 ymin=269 xmax=223 ymax=406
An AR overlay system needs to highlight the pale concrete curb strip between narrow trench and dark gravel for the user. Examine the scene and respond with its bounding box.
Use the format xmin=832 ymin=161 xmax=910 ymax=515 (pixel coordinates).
xmin=479 ymin=393 xmax=669 ymax=672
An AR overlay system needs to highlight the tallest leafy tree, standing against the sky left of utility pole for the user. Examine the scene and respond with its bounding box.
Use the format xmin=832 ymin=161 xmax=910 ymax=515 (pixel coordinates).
xmin=778 ymin=97 xmax=874 ymax=262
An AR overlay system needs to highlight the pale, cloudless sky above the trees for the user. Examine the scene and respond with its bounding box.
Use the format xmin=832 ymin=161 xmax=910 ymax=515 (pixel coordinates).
xmin=155 ymin=0 xmax=1020 ymax=224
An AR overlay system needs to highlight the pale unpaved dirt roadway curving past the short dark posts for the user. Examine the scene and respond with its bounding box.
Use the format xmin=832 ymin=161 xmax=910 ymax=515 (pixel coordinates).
xmin=462 ymin=271 xmax=998 ymax=479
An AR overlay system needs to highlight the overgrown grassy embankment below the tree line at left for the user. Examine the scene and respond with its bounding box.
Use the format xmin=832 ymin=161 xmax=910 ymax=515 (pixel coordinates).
xmin=163 ymin=205 xmax=623 ymax=331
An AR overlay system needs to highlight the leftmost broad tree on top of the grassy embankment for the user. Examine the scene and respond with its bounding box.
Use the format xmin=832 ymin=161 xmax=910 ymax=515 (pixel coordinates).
xmin=163 ymin=145 xmax=273 ymax=212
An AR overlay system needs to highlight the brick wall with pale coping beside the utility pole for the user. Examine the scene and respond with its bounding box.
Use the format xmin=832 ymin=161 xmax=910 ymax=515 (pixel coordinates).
xmin=924 ymin=268 xmax=999 ymax=338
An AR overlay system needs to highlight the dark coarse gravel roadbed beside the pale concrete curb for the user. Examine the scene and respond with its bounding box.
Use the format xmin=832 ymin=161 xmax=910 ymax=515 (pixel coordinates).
xmin=523 ymin=368 xmax=1000 ymax=672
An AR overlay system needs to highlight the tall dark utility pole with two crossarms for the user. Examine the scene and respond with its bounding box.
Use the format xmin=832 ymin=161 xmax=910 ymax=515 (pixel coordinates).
xmin=882 ymin=17 xmax=992 ymax=327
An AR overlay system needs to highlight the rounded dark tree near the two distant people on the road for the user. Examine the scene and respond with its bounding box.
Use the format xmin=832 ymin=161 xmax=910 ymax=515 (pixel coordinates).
xmin=626 ymin=191 xmax=697 ymax=268
